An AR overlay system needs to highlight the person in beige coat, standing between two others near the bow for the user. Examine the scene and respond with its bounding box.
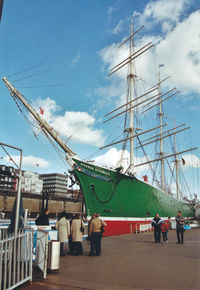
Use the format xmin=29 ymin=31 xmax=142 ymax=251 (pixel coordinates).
xmin=71 ymin=213 xmax=84 ymax=256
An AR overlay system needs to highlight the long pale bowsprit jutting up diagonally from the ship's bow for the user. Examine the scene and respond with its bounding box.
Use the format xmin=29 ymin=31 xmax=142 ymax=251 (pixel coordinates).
xmin=3 ymin=78 xmax=78 ymax=166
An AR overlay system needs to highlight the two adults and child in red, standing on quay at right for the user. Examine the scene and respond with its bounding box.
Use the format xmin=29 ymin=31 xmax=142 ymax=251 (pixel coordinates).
xmin=151 ymin=210 xmax=185 ymax=244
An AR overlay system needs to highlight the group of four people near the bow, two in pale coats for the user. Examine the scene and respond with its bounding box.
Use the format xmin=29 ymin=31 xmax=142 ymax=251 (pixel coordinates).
xmin=35 ymin=209 xmax=107 ymax=256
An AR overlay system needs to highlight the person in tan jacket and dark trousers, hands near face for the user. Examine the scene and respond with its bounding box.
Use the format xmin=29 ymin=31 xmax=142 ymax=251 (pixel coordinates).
xmin=89 ymin=213 xmax=107 ymax=256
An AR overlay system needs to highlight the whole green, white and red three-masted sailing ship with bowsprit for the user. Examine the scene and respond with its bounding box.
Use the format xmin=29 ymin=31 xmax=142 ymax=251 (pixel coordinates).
xmin=3 ymin=19 xmax=197 ymax=235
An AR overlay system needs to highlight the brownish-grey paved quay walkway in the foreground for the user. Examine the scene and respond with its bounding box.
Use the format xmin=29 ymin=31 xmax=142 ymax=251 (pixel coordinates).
xmin=21 ymin=229 xmax=200 ymax=290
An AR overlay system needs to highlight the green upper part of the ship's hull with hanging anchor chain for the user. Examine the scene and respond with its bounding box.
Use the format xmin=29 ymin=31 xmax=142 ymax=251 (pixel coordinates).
xmin=73 ymin=159 xmax=194 ymax=218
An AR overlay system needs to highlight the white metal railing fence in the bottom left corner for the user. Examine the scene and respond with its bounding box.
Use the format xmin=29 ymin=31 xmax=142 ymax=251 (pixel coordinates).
xmin=0 ymin=229 xmax=33 ymax=290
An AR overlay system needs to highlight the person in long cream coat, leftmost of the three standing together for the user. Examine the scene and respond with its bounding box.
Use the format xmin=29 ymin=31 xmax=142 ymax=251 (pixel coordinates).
xmin=56 ymin=211 xmax=70 ymax=256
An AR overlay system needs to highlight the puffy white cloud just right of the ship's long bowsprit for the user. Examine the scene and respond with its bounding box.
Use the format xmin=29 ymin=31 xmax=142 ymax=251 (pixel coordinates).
xmin=34 ymin=97 xmax=105 ymax=146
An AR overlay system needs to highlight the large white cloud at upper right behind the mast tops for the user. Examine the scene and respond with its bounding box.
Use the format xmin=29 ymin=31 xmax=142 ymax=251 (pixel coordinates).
xmin=96 ymin=5 xmax=200 ymax=105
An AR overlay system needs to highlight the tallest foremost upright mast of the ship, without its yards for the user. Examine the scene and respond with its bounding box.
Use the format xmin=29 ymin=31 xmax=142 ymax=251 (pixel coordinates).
xmin=127 ymin=17 xmax=134 ymax=173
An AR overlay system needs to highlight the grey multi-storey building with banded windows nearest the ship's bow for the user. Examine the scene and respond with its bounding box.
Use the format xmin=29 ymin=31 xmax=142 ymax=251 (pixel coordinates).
xmin=40 ymin=173 xmax=68 ymax=197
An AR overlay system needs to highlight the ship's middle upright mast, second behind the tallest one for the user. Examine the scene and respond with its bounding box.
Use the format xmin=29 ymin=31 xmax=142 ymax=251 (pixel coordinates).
xmin=158 ymin=65 xmax=165 ymax=190
